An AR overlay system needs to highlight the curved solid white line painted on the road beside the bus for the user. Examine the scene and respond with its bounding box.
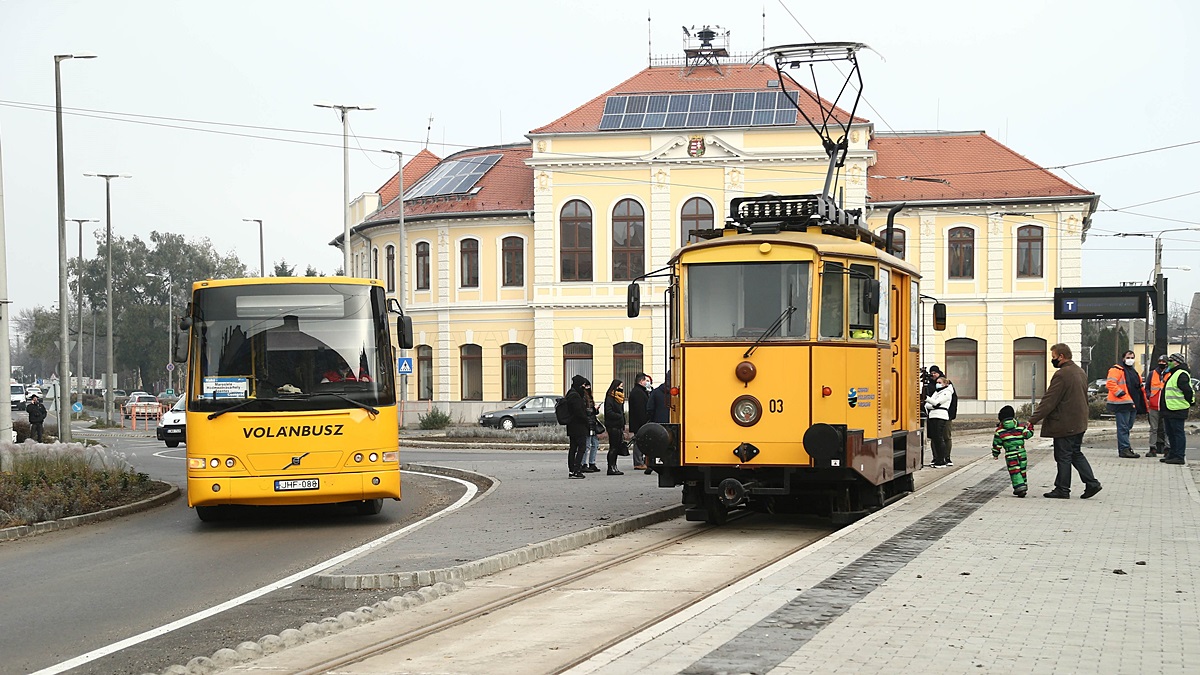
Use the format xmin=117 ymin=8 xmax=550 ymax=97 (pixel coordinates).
xmin=32 ymin=471 xmax=479 ymax=675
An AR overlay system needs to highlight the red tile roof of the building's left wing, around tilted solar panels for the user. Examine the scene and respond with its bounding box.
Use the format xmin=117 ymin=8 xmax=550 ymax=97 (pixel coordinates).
xmin=362 ymin=143 xmax=533 ymax=226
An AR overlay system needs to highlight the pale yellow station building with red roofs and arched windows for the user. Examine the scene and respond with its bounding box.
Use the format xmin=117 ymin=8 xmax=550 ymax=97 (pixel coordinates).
xmin=332 ymin=51 xmax=1099 ymax=422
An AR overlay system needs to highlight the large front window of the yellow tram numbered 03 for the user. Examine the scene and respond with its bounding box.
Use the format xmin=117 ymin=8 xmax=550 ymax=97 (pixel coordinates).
xmin=686 ymin=262 xmax=811 ymax=341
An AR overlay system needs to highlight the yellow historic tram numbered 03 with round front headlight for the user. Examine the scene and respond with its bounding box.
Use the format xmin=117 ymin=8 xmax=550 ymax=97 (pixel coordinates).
xmin=629 ymin=195 xmax=946 ymax=524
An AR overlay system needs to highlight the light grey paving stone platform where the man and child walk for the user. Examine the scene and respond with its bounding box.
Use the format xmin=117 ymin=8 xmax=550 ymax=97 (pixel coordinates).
xmin=577 ymin=432 xmax=1200 ymax=675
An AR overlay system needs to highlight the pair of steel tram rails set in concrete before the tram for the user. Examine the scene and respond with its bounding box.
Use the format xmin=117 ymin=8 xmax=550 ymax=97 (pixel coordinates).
xmin=295 ymin=513 xmax=835 ymax=675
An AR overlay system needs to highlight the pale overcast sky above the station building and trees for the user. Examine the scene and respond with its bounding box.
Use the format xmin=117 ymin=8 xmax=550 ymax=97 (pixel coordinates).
xmin=0 ymin=0 xmax=1200 ymax=310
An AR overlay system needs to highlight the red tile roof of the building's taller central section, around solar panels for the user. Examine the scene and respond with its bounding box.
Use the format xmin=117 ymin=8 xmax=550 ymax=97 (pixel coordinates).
xmin=529 ymin=64 xmax=868 ymax=133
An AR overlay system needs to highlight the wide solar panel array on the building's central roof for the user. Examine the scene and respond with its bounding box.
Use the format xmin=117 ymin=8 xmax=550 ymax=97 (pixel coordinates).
xmin=600 ymin=91 xmax=797 ymax=131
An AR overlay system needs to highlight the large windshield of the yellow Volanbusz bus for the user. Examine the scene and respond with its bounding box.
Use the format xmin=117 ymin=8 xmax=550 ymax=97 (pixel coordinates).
xmin=187 ymin=283 xmax=395 ymax=412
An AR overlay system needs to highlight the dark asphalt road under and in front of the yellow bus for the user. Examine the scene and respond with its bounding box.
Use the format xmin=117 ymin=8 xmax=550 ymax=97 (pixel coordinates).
xmin=0 ymin=429 xmax=464 ymax=674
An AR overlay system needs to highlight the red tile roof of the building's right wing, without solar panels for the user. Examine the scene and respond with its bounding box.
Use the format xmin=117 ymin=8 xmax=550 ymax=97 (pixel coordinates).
xmin=866 ymin=131 xmax=1092 ymax=202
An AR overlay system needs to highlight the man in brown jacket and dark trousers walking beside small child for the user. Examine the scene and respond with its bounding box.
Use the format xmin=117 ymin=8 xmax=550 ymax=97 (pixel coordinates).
xmin=1030 ymin=342 xmax=1103 ymax=500
